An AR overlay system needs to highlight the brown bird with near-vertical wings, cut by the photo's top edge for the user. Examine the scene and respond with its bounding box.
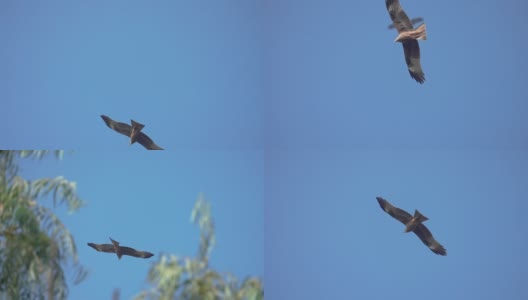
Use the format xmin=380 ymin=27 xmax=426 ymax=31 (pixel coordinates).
xmin=385 ymin=0 xmax=427 ymax=84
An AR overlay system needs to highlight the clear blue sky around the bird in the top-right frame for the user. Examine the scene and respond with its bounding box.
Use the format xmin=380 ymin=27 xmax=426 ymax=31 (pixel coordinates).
xmin=266 ymin=0 xmax=528 ymax=148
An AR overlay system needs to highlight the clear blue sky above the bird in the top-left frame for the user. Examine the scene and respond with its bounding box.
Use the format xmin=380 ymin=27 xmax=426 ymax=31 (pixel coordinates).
xmin=0 ymin=0 xmax=263 ymax=151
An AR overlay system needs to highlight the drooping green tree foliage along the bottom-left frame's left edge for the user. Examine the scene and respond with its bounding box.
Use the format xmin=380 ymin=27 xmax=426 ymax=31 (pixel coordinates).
xmin=0 ymin=150 xmax=87 ymax=299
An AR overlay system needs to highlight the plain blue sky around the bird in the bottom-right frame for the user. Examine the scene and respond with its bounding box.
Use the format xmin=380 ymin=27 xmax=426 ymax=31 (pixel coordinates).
xmin=265 ymin=149 xmax=528 ymax=299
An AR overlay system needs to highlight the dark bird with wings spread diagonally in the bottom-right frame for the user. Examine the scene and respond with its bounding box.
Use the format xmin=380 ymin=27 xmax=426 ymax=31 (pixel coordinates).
xmin=376 ymin=197 xmax=447 ymax=256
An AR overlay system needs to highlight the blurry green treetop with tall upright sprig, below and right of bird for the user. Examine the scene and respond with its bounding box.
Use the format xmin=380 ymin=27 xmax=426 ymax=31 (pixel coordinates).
xmin=136 ymin=194 xmax=264 ymax=300
